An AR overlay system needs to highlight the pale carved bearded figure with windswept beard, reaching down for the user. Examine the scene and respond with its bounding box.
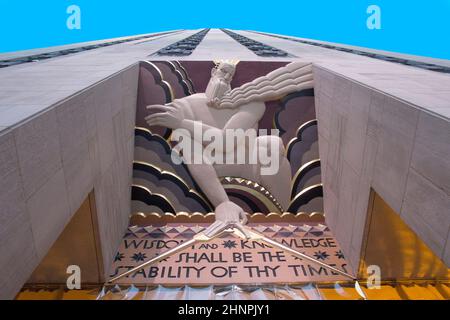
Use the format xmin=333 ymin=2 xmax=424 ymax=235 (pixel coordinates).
xmin=146 ymin=62 xmax=313 ymax=237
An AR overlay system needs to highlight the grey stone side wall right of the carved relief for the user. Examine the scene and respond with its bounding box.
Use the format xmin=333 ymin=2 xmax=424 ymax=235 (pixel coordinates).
xmin=314 ymin=66 xmax=450 ymax=271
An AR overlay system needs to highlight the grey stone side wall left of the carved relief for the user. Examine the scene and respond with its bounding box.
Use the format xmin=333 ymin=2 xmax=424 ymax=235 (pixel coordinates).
xmin=0 ymin=64 xmax=138 ymax=299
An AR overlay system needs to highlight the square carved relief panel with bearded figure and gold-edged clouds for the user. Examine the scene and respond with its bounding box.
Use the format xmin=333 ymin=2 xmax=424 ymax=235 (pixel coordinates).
xmin=132 ymin=61 xmax=323 ymax=220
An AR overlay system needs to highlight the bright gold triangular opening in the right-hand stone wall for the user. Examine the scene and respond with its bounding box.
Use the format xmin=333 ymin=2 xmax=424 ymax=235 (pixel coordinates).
xmin=359 ymin=191 xmax=450 ymax=281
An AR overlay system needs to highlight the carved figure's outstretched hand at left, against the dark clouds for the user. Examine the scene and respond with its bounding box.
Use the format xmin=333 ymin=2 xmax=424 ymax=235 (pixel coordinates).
xmin=145 ymin=103 xmax=184 ymax=129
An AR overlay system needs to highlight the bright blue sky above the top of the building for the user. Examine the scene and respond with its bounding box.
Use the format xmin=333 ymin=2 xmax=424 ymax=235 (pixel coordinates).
xmin=0 ymin=0 xmax=450 ymax=59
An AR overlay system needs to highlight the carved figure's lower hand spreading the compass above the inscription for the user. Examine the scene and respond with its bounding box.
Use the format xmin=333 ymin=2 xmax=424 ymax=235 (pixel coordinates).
xmin=205 ymin=201 xmax=250 ymax=238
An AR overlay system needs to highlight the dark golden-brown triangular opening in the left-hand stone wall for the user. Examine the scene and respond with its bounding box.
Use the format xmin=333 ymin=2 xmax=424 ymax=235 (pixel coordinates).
xmin=27 ymin=193 xmax=104 ymax=284
